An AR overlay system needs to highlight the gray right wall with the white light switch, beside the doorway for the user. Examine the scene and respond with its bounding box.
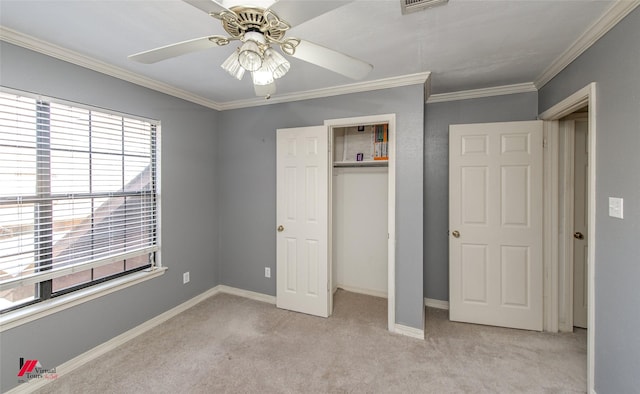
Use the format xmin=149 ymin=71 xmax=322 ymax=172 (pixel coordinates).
xmin=539 ymin=8 xmax=640 ymax=394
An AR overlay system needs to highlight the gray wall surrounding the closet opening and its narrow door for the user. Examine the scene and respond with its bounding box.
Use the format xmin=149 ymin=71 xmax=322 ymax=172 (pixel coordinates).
xmin=216 ymin=85 xmax=424 ymax=328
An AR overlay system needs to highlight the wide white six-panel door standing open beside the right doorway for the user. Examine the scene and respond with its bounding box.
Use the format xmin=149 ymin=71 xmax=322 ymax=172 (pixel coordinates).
xmin=449 ymin=121 xmax=543 ymax=330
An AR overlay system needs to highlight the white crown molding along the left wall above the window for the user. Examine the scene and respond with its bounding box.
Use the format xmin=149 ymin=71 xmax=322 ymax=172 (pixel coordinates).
xmin=0 ymin=26 xmax=225 ymax=110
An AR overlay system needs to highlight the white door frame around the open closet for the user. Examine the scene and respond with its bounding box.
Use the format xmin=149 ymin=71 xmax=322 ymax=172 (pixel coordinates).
xmin=324 ymin=114 xmax=396 ymax=332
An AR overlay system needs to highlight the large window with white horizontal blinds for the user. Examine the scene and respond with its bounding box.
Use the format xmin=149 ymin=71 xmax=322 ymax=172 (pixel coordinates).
xmin=0 ymin=91 xmax=158 ymax=312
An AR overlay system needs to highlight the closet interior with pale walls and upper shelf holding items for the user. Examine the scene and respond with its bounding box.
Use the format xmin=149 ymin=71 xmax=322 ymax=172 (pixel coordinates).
xmin=331 ymin=125 xmax=389 ymax=298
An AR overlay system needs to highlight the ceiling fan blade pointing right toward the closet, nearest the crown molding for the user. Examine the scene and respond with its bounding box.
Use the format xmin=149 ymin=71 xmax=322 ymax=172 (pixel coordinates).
xmin=291 ymin=40 xmax=373 ymax=79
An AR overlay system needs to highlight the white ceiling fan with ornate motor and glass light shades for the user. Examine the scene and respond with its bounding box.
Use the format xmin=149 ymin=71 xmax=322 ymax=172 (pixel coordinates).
xmin=129 ymin=0 xmax=373 ymax=98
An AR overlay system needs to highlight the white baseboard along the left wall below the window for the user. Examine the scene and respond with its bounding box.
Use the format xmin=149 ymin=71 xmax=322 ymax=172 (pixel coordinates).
xmin=7 ymin=286 xmax=220 ymax=394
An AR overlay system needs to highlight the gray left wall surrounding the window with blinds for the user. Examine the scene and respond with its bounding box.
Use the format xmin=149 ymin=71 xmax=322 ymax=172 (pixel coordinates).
xmin=0 ymin=42 xmax=219 ymax=392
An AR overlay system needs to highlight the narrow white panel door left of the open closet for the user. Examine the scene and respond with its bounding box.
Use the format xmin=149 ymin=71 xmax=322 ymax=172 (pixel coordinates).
xmin=276 ymin=126 xmax=330 ymax=317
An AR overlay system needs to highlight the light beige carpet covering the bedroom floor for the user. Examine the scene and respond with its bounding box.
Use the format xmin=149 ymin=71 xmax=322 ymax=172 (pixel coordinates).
xmin=33 ymin=291 xmax=586 ymax=393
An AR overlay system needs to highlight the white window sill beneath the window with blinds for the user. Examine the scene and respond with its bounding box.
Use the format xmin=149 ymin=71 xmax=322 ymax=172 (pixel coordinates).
xmin=0 ymin=267 xmax=167 ymax=332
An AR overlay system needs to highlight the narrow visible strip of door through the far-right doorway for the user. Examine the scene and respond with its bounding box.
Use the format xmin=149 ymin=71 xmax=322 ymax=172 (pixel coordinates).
xmin=573 ymin=120 xmax=589 ymax=328
